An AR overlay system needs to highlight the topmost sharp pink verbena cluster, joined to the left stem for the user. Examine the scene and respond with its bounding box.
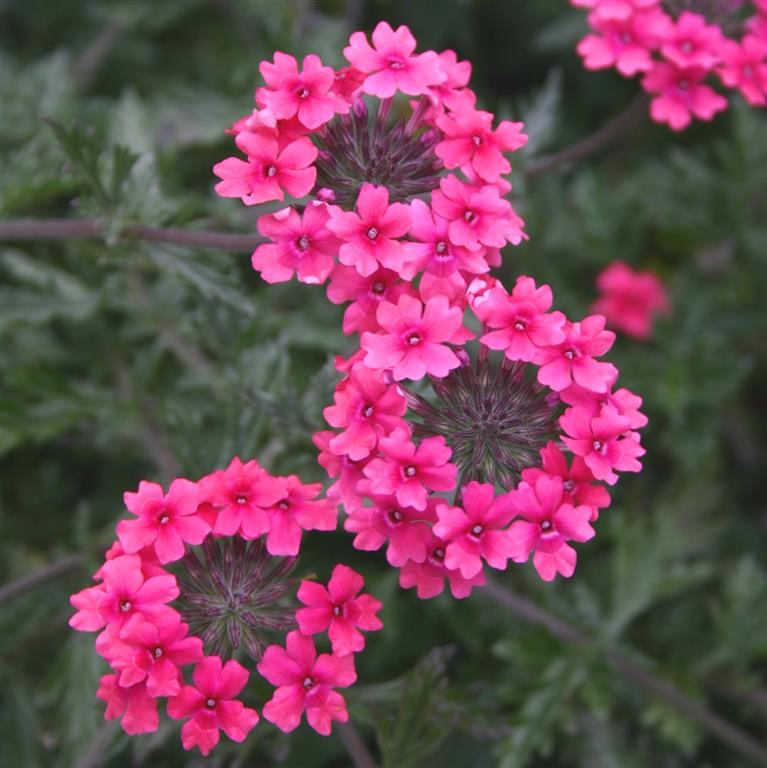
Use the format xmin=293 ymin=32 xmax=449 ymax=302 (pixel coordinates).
xmin=214 ymin=22 xmax=527 ymax=296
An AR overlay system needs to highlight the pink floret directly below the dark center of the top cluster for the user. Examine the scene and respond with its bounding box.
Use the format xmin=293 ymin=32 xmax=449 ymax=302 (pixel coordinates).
xmin=328 ymin=184 xmax=410 ymax=277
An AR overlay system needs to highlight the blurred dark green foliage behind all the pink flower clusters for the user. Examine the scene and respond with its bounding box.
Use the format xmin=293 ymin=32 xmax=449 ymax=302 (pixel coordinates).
xmin=0 ymin=0 xmax=767 ymax=768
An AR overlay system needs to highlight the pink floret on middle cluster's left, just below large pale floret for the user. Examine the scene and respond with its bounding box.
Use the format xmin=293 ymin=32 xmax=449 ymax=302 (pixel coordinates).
xmin=323 ymin=365 xmax=407 ymax=461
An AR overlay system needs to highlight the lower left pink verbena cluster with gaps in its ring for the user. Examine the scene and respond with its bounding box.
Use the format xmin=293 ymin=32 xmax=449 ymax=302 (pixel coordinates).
xmin=69 ymin=458 xmax=382 ymax=755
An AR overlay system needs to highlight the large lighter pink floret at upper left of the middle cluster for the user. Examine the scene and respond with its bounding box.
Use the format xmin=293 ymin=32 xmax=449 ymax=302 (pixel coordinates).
xmin=360 ymin=294 xmax=465 ymax=381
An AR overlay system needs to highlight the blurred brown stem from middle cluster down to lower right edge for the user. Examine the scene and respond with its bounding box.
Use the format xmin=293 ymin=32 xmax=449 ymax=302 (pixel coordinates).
xmin=481 ymin=581 xmax=767 ymax=765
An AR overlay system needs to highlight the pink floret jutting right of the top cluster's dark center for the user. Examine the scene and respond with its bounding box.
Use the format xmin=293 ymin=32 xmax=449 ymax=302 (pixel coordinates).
xmin=435 ymin=109 xmax=527 ymax=183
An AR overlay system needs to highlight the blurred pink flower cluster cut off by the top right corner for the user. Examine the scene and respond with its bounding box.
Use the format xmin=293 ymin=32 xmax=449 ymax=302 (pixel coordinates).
xmin=570 ymin=0 xmax=767 ymax=131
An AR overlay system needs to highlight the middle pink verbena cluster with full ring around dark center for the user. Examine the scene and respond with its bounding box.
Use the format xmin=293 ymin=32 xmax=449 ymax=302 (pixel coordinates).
xmin=314 ymin=276 xmax=647 ymax=598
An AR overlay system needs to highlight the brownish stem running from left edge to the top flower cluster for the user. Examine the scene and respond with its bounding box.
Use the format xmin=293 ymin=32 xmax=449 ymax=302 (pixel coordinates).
xmin=0 ymin=219 xmax=265 ymax=251
